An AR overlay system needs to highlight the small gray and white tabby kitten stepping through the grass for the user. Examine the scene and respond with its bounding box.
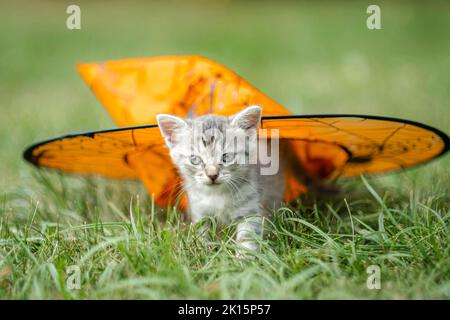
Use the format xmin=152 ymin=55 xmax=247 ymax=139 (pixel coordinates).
xmin=157 ymin=106 xmax=284 ymax=250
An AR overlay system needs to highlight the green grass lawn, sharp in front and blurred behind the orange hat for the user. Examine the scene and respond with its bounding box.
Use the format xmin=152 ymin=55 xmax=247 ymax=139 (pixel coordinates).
xmin=0 ymin=1 xmax=450 ymax=299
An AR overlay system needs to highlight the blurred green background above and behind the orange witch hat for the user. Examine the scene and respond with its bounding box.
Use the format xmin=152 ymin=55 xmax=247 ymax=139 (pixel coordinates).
xmin=0 ymin=1 xmax=450 ymax=186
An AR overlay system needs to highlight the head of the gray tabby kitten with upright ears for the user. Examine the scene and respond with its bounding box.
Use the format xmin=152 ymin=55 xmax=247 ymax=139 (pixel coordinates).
xmin=157 ymin=106 xmax=261 ymax=187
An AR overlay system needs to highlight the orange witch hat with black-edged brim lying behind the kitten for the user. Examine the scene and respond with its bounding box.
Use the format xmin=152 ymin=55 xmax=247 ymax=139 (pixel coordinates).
xmin=25 ymin=56 xmax=449 ymax=208
